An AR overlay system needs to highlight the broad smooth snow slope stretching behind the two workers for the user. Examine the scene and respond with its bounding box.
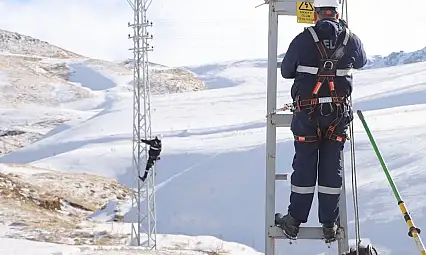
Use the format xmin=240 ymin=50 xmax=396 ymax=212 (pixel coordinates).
xmin=0 ymin=51 xmax=426 ymax=255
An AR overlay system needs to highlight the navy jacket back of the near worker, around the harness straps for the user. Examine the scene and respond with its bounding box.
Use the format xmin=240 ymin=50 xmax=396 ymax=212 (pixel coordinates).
xmin=281 ymin=20 xmax=367 ymax=99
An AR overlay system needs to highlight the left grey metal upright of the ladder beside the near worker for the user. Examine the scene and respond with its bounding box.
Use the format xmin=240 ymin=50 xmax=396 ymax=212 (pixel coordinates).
xmin=265 ymin=1 xmax=278 ymax=255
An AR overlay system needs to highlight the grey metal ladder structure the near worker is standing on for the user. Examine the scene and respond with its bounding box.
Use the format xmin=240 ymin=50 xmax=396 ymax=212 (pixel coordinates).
xmin=265 ymin=0 xmax=349 ymax=255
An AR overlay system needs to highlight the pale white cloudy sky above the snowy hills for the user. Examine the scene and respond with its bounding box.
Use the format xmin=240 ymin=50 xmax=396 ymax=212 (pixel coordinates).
xmin=0 ymin=0 xmax=426 ymax=66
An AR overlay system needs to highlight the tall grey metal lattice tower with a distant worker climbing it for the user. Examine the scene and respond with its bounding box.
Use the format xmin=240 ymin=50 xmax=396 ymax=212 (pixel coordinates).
xmin=127 ymin=0 xmax=157 ymax=249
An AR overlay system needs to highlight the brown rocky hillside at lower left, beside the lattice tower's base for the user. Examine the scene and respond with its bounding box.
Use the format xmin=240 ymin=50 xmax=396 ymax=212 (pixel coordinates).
xmin=0 ymin=164 xmax=131 ymax=244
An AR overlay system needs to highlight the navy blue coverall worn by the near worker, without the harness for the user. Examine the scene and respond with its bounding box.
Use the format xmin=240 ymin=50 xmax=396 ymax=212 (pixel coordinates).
xmin=281 ymin=20 xmax=367 ymax=224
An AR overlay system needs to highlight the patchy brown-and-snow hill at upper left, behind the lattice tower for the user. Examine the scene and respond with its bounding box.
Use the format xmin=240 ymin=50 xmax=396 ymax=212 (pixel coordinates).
xmin=0 ymin=30 xmax=205 ymax=154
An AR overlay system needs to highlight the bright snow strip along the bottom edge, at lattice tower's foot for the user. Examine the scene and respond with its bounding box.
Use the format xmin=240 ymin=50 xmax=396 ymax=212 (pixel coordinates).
xmin=0 ymin=230 xmax=261 ymax=255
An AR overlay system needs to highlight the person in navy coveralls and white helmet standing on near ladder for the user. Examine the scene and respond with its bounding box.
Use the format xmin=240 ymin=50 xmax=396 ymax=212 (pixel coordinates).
xmin=275 ymin=0 xmax=367 ymax=243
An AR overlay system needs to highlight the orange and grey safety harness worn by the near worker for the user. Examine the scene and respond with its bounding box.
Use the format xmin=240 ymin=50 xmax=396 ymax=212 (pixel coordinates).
xmin=294 ymin=27 xmax=352 ymax=143
